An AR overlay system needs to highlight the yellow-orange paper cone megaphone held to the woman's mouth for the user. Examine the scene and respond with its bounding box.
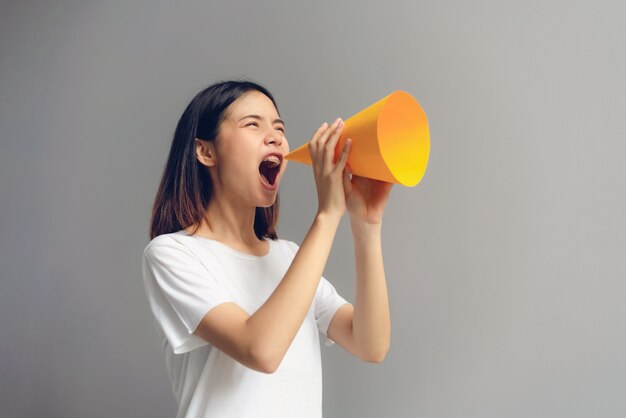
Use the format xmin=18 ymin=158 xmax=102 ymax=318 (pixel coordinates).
xmin=285 ymin=91 xmax=430 ymax=187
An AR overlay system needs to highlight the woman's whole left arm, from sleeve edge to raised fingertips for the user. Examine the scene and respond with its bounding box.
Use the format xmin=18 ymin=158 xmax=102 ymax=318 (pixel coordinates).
xmin=194 ymin=119 xmax=351 ymax=373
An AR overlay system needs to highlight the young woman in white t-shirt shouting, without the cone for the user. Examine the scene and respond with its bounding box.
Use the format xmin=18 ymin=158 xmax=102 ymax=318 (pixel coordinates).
xmin=142 ymin=81 xmax=392 ymax=418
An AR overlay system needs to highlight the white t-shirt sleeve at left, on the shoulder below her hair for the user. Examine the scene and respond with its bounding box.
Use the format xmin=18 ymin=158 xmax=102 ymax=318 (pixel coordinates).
xmin=142 ymin=239 xmax=234 ymax=354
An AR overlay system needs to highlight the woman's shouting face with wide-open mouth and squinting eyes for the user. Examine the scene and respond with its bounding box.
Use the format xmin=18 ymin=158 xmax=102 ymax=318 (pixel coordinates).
xmin=199 ymin=90 xmax=289 ymax=207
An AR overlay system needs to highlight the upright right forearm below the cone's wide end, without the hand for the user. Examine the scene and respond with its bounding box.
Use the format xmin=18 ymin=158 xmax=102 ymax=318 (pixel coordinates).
xmin=352 ymin=222 xmax=391 ymax=360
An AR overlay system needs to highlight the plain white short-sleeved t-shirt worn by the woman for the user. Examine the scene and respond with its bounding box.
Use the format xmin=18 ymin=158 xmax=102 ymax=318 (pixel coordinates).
xmin=142 ymin=230 xmax=348 ymax=418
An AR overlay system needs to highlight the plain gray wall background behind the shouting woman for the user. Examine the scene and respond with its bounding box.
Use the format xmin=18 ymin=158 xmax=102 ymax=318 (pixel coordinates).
xmin=0 ymin=1 xmax=626 ymax=417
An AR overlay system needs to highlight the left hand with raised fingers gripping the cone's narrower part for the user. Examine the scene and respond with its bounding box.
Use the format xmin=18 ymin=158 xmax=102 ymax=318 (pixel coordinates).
xmin=309 ymin=118 xmax=352 ymax=221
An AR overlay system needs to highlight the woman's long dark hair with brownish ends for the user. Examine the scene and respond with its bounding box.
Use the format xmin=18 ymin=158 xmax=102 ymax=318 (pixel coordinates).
xmin=149 ymin=80 xmax=280 ymax=240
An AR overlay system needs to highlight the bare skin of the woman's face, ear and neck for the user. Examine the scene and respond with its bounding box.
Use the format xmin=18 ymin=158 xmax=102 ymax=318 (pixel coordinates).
xmin=188 ymin=91 xmax=289 ymax=255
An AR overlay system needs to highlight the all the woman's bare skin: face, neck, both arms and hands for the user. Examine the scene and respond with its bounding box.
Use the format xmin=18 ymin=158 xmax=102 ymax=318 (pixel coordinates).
xmin=188 ymin=91 xmax=392 ymax=373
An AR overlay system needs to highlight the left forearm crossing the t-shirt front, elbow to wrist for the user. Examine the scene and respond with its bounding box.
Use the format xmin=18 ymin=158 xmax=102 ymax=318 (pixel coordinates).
xmin=246 ymin=215 xmax=339 ymax=367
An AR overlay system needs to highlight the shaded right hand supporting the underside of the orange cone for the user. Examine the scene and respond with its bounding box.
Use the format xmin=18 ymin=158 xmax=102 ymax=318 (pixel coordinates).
xmin=343 ymin=167 xmax=393 ymax=224
